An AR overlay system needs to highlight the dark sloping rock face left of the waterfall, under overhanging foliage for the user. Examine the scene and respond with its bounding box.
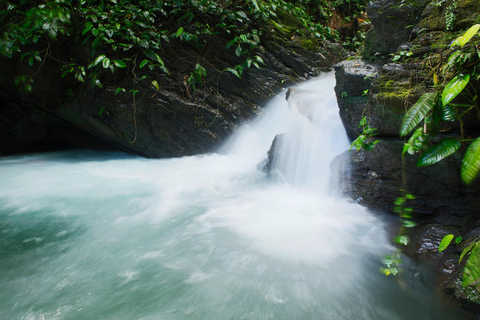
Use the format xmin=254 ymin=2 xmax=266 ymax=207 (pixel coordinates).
xmin=0 ymin=36 xmax=345 ymax=157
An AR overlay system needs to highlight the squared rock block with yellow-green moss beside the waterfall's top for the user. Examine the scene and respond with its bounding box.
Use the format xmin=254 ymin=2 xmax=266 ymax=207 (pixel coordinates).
xmin=335 ymin=59 xmax=430 ymax=140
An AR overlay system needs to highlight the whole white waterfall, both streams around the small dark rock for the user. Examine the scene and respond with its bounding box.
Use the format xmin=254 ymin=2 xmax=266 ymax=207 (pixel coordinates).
xmin=220 ymin=72 xmax=349 ymax=195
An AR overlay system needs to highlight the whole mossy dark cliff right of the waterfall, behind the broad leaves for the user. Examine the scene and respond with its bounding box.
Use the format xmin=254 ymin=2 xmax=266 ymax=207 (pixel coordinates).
xmin=335 ymin=0 xmax=480 ymax=309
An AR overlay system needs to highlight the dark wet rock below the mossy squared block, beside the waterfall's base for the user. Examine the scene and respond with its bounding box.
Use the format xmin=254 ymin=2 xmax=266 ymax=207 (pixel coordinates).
xmin=336 ymin=139 xmax=480 ymax=219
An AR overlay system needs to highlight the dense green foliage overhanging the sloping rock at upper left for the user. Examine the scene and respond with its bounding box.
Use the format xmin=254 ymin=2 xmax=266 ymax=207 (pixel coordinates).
xmin=0 ymin=0 xmax=367 ymax=94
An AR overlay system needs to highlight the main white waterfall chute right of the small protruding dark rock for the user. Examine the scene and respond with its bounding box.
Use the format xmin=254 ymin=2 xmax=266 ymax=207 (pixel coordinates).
xmin=266 ymin=73 xmax=349 ymax=194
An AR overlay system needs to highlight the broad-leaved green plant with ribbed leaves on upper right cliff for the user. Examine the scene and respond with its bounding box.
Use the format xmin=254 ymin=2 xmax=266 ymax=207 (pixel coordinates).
xmin=400 ymin=24 xmax=480 ymax=184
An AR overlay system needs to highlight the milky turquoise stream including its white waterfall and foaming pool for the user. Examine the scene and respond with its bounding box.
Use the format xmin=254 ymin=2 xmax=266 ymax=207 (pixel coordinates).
xmin=0 ymin=73 xmax=467 ymax=320
